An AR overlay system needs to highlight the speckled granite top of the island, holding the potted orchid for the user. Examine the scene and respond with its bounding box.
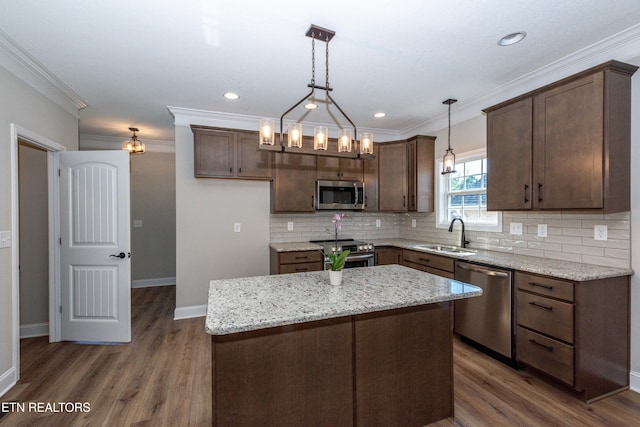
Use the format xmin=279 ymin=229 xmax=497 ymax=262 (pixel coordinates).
xmin=206 ymin=265 xmax=482 ymax=335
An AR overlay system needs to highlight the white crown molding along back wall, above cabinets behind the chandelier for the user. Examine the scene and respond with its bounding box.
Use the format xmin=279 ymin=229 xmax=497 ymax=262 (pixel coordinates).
xmin=167 ymin=106 xmax=402 ymax=142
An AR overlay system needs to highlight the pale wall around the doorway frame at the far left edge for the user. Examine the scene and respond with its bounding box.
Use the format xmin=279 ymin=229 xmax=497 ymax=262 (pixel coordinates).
xmin=0 ymin=61 xmax=78 ymax=395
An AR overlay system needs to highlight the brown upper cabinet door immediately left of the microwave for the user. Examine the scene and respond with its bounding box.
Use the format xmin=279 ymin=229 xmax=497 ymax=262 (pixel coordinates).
xmin=271 ymin=153 xmax=316 ymax=212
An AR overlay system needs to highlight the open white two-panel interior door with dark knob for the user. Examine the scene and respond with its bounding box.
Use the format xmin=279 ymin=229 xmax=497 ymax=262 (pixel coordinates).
xmin=60 ymin=150 xmax=131 ymax=342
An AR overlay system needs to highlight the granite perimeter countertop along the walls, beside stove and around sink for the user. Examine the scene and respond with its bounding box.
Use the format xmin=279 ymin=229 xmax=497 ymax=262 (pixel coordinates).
xmin=270 ymin=239 xmax=633 ymax=282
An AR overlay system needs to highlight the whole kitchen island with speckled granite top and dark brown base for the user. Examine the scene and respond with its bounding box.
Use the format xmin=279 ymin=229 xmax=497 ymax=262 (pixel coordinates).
xmin=206 ymin=265 xmax=482 ymax=426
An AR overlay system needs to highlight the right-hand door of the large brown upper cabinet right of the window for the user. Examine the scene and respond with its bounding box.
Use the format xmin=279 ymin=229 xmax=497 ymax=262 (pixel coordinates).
xmin=536 ymin=72 xmax=604 ymax=209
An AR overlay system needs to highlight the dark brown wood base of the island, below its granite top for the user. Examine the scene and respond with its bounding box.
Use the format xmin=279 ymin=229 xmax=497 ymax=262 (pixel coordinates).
xmin=211 ymin=302 xmax=453 ymax=427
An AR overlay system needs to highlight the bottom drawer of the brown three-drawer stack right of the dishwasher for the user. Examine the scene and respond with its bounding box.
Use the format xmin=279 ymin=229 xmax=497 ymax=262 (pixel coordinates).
xmin=516 ymin=326 xmax=575 ymax=386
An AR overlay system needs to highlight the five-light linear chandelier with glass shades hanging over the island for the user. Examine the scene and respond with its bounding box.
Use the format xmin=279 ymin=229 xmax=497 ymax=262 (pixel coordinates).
xmin=259 ymin=25 xmax=373 ymax=159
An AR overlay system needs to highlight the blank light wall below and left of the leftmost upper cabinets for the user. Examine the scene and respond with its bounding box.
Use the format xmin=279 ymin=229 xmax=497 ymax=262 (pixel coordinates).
xmin=176 ymin=123 xmax=270 ymax=317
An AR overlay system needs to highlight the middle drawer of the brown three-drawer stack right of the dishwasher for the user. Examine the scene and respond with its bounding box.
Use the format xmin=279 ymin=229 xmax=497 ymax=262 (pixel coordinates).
xmin=516 ymin=290 xmax=573 ymax=344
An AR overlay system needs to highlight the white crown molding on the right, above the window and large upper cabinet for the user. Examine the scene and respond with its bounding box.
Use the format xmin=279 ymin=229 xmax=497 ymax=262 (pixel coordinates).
xmin=400 ymin=24 xmax=640 ymax=138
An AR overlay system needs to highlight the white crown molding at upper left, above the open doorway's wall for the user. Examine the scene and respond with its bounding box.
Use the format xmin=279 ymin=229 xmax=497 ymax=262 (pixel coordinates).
xmin=0 ymin=30 xmax=87 ymax=117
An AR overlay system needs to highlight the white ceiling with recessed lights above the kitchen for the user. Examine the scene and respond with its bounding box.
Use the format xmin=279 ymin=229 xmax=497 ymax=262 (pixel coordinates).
xmin=0 ymin=0 xmax=640 ymax=140
